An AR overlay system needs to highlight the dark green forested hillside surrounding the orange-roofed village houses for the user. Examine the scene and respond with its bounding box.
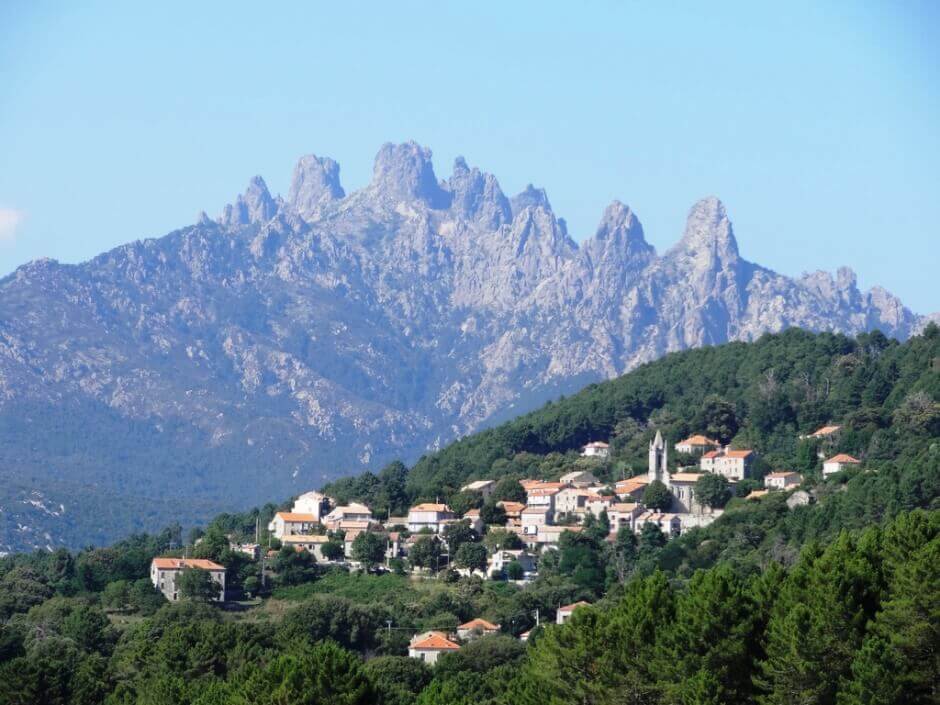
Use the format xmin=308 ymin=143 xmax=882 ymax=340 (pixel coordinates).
xmin=0 ymin=326 xmax=940 ymax=705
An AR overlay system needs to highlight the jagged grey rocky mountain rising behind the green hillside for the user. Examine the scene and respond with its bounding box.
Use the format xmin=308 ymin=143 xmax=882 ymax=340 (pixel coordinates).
xmin=0 ymin=143 xmax=923 ymax=551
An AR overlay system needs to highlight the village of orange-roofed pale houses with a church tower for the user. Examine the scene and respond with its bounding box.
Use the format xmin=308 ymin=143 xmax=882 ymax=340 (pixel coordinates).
xmin=150 ymin=425 xmax=860 ymax=664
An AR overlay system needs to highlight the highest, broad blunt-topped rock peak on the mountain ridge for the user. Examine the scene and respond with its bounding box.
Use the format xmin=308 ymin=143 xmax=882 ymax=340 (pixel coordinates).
xmin=370 ymin=142 xmax=448 ymax=208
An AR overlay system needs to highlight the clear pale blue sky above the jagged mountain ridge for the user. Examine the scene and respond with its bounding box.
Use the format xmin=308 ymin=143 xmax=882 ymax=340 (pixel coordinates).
xmin=0 ymin=0 xmax=940 ymax=313
